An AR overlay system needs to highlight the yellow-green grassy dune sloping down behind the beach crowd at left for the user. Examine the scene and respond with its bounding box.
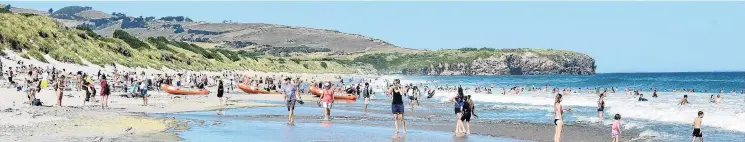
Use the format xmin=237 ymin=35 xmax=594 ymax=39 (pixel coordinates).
xmin=0 ymin=13 xmax=359 ymax=73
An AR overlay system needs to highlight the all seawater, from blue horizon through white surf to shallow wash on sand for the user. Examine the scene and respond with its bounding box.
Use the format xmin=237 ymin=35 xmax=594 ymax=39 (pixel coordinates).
xmin=159 ymin=73 xmax=745 ymax=142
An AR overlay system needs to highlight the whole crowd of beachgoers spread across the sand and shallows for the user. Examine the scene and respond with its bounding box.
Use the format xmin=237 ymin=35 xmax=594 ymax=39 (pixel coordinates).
xmin=0 ymin=55 xmax=745 ymax=141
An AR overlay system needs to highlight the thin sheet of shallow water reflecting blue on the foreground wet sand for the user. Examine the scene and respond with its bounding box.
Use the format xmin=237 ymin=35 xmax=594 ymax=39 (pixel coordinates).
xmin=164 ymin=99 xmax=644 ymax=142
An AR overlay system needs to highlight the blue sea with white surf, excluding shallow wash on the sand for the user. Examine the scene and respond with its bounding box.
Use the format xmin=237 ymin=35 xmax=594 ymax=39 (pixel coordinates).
xmin=390 ymin=72 xmax=745 ymax=141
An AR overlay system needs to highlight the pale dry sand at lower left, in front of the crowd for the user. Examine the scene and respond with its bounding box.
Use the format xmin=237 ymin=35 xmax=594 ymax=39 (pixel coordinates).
xmin=0 ymin=84 xmax=290 ymax=141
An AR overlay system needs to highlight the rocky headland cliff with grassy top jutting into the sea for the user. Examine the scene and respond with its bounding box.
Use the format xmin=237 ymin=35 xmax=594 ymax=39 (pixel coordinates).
xmin=401 ymin=52 xmax=596 ymax=76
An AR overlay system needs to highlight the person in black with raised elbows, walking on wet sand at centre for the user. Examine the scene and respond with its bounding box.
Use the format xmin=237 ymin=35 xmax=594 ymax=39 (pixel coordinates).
xmin=389 ymin=79 xmax=407 ymax=138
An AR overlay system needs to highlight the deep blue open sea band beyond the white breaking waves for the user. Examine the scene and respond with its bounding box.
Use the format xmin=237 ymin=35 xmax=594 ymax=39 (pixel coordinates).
xmin=396 ymin=72 xmax=745 ymax=93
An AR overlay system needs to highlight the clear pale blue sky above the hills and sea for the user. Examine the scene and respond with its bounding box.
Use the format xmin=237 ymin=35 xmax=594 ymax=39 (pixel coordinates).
xmin=5 ymin=2 xmax=745 ymax=73
